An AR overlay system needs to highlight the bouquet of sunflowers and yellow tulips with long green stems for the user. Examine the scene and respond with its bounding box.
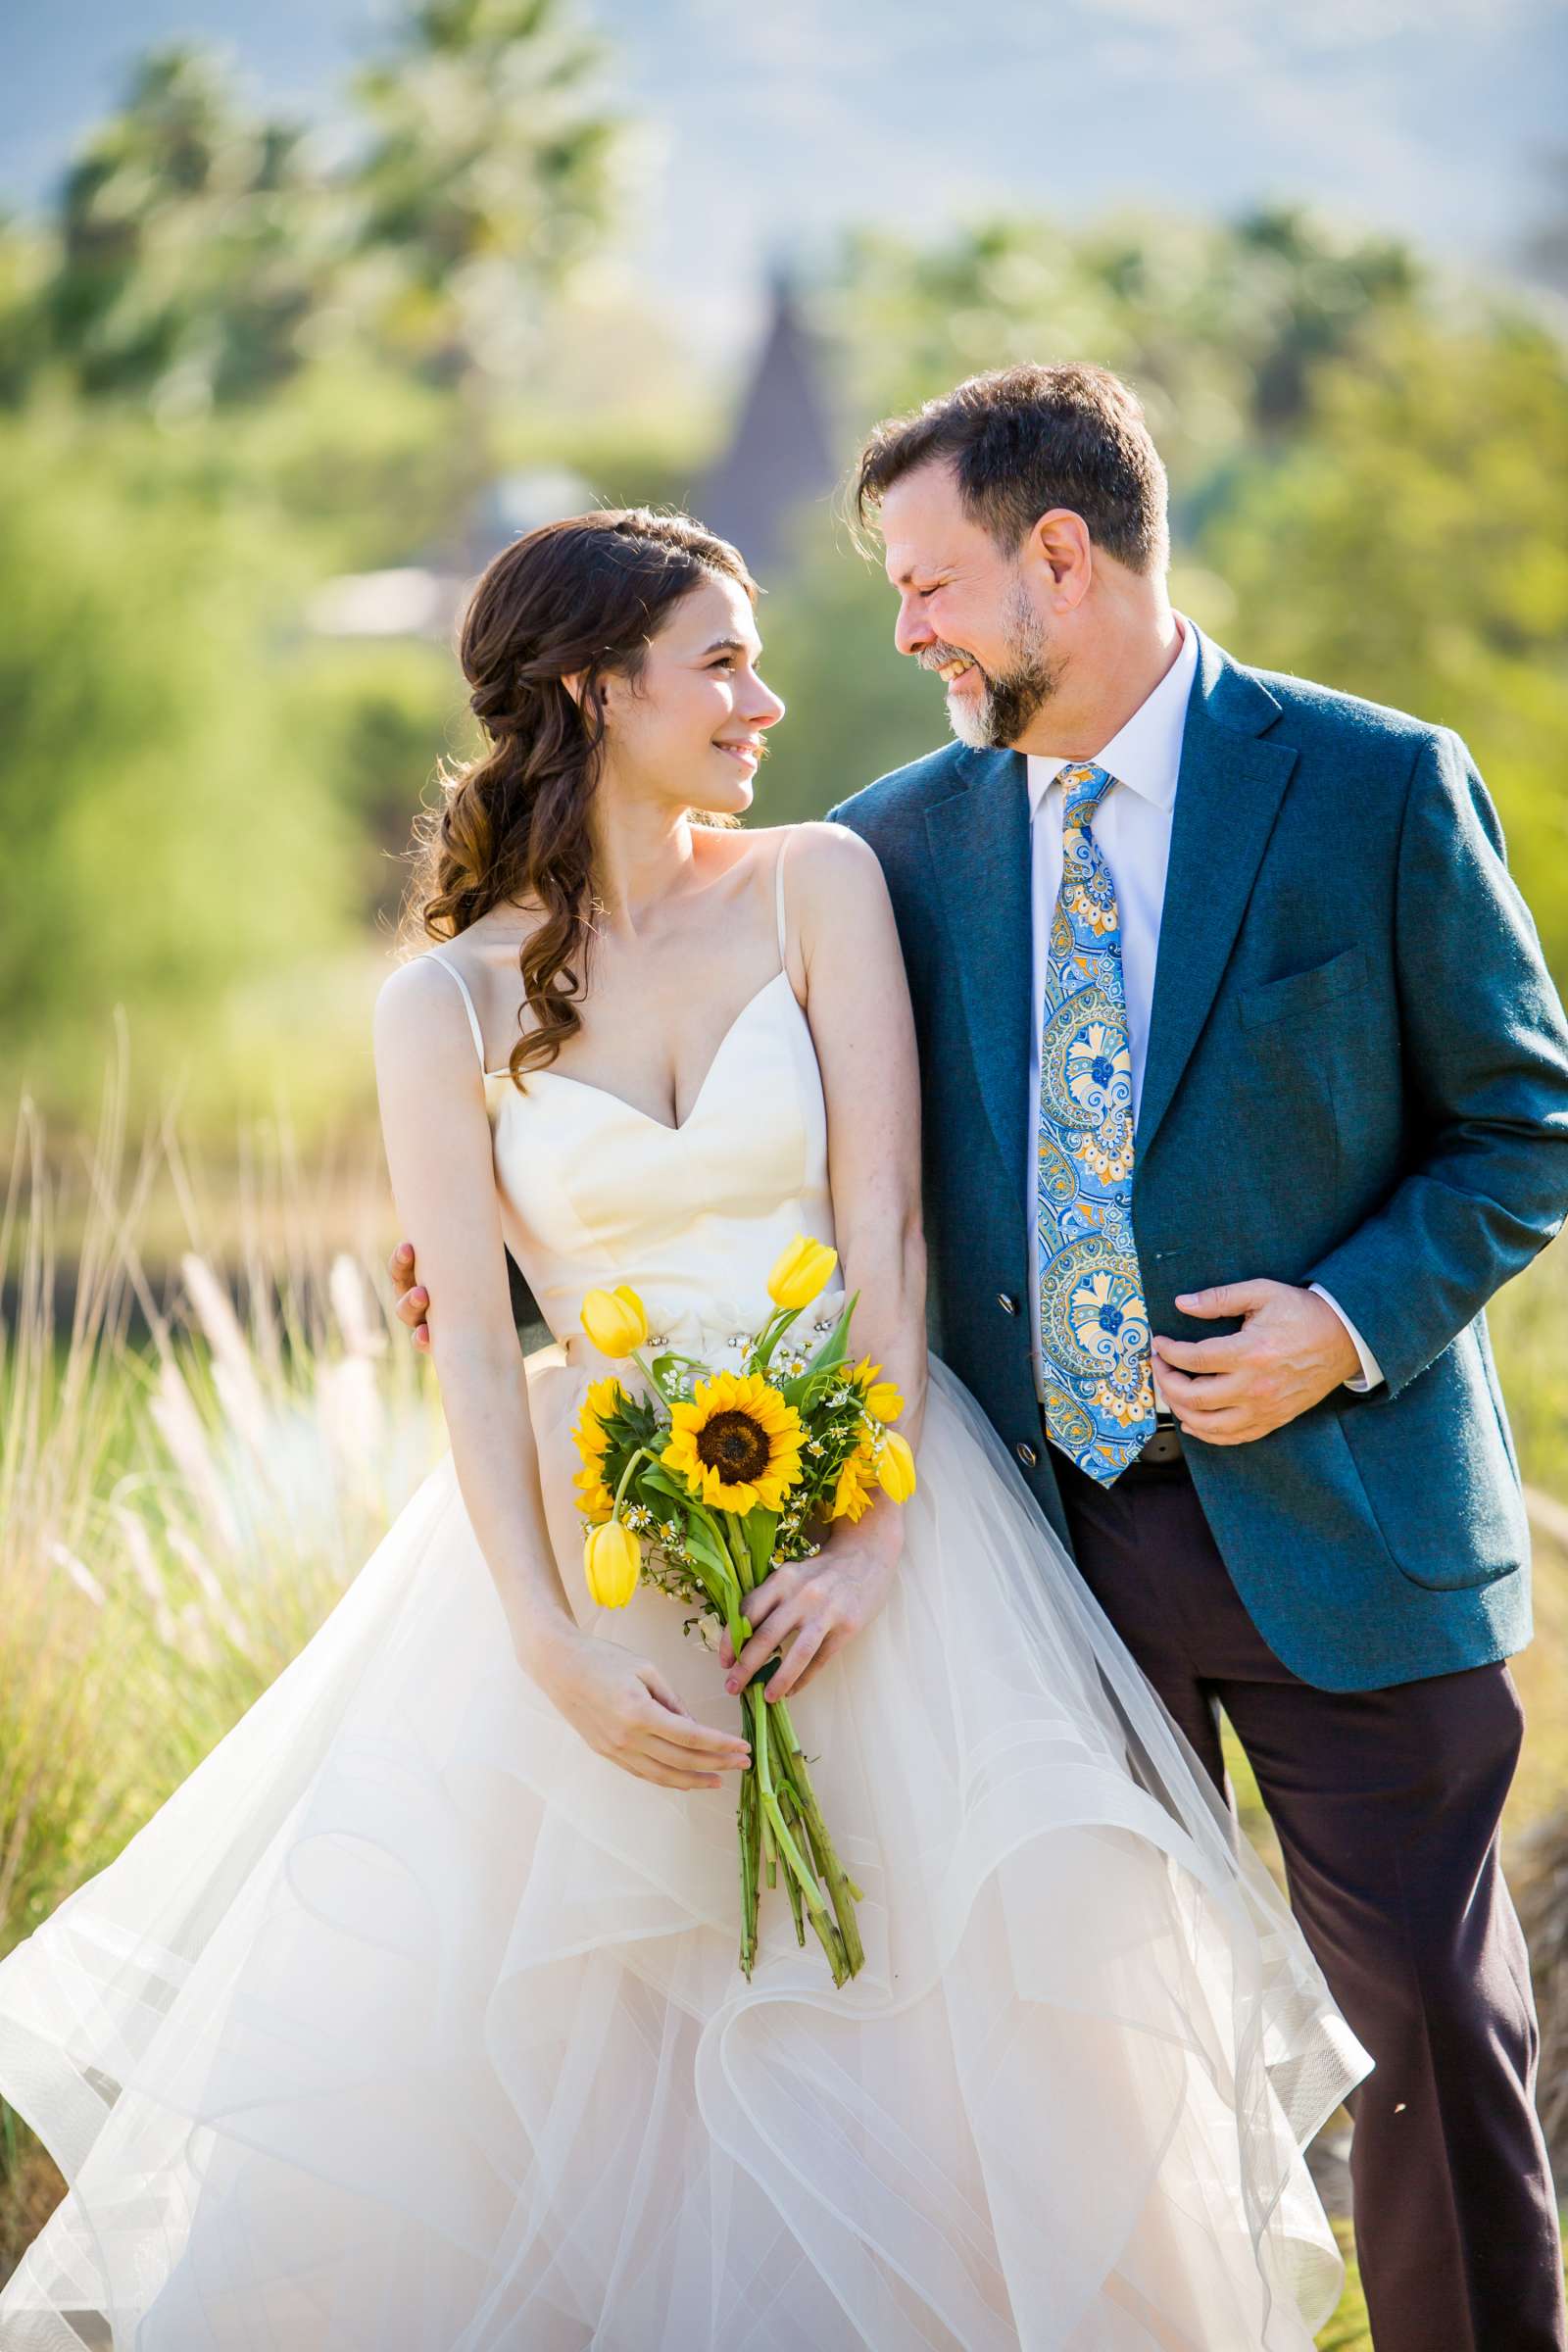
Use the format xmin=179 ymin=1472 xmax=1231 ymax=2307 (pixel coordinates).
xmin=573 ymin=1235 xmax=914 ymax=1985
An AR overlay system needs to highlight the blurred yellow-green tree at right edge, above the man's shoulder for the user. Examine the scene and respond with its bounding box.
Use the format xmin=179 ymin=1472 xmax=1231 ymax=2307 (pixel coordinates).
xmin=1201 ymin=311 xmax=1568 ymax=981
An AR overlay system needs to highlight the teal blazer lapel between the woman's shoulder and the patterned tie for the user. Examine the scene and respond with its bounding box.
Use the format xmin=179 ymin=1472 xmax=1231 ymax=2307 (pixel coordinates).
xmin=926 ymin=751 xmax=1032 ymax=1198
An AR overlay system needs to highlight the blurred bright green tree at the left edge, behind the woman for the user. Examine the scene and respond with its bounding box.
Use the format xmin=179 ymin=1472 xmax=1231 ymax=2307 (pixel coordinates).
xmin=0 ymin=410 xmax=360 ymax=1110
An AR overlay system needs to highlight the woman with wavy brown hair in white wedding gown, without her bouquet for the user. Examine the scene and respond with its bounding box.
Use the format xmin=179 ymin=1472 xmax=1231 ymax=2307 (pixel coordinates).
xmin=0 ymin=511 xmax=1368 ymax=2352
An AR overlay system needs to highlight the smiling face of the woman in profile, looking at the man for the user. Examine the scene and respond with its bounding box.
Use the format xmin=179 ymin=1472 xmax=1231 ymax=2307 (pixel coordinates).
xmin=604 ymin=578 xmax=783 ymax=816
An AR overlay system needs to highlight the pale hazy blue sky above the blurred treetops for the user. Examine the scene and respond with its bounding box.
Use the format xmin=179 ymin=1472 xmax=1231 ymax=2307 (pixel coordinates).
xmin=0 ymin=0 xmax=1568 ymax=351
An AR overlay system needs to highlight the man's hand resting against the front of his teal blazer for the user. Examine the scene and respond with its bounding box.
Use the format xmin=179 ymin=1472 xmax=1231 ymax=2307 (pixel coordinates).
xmin=1152 ymin=1282 xmax=1361 ymax=1446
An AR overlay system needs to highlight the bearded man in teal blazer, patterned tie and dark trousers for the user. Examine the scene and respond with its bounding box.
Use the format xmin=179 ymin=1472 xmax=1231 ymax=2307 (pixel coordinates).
xmin=830 ymin=367 xmax=1568 ymax=2352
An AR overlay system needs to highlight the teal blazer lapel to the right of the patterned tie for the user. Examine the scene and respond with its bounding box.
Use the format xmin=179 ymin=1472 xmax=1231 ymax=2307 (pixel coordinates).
xmin=1133 ymin=630 xmax=1298 ymax=1164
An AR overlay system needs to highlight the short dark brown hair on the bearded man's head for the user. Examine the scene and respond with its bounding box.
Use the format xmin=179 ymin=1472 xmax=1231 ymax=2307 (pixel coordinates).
xmin=854 ymin=365 xmax=1171 ymax=571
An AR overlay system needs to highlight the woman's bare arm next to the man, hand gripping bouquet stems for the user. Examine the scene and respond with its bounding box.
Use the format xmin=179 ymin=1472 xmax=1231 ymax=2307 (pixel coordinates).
xmin=721 ymin=825 xmax=926 ymax=1698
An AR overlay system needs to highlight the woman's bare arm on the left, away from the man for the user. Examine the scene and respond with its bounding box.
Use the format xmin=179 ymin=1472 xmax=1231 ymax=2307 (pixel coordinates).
xmin=373 ymin=959 xmax=748 ymax=1788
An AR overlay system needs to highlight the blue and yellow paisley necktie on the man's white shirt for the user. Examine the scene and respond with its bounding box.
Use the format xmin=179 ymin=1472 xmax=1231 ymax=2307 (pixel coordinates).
xmin=1034 ymin=766 xmax=1154 ymax=1487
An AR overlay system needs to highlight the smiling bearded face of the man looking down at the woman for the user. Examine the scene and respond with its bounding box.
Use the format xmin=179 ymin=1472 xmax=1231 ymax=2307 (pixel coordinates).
xmin=882 ymin=461 xmax=1062 ymax=748
